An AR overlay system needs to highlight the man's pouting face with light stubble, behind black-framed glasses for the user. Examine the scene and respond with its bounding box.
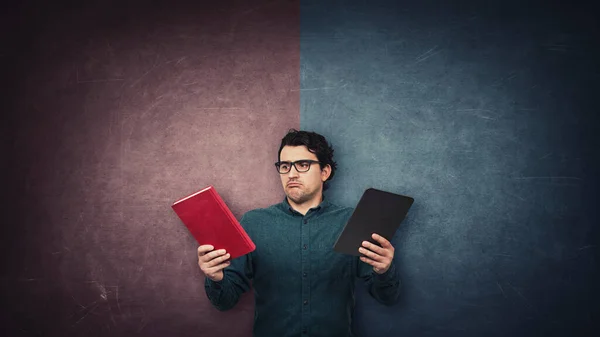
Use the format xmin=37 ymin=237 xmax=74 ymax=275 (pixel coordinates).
xmin=280 ymin=146 xmax=331 ymax=204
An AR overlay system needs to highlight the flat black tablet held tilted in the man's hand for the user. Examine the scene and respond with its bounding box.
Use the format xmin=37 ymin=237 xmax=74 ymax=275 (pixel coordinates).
xmin=333 ymin=188 xmax=414 ymax=256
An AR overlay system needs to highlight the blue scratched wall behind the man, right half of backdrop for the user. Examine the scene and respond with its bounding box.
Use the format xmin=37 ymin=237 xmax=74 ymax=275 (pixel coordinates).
xmin=300 ymin=0 xmax=600 ymax=337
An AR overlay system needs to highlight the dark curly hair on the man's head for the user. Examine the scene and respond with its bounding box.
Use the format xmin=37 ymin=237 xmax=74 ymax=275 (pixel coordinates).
xmin=277 ymin=129 xmax=337 ymax=190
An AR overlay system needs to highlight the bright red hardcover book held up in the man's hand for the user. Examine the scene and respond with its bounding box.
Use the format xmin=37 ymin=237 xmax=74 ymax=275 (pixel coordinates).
xmin=171 ymin=185 xmax=256 ymax=259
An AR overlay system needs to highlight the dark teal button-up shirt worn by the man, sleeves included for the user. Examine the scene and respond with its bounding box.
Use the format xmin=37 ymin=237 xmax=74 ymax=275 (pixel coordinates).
xmin=205 ymin=199 xmax=400 ymax=337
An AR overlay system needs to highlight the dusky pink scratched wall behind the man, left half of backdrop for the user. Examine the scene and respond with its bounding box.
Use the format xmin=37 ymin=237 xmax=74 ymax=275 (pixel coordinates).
xmin=1 ymin=1 xmax=300 ymax=336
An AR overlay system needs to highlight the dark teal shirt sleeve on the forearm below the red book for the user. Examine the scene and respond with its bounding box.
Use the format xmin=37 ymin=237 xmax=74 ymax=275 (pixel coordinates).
xmin=204 ymin=216 xmax=254 ymax=311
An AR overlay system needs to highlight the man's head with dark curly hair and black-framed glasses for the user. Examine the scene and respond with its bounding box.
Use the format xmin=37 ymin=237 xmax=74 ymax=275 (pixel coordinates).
xmin=276 ymin=129 xmax=337 ymax=204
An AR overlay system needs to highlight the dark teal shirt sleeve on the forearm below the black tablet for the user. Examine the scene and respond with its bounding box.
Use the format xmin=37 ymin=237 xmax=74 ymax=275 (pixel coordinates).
xmin=355 ymin=257 xmax=401 ymax=305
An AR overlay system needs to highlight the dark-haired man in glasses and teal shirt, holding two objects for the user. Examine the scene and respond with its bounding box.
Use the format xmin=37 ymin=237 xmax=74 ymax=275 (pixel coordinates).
xmin=198 ymin=129 xmax=400 ymax=337
